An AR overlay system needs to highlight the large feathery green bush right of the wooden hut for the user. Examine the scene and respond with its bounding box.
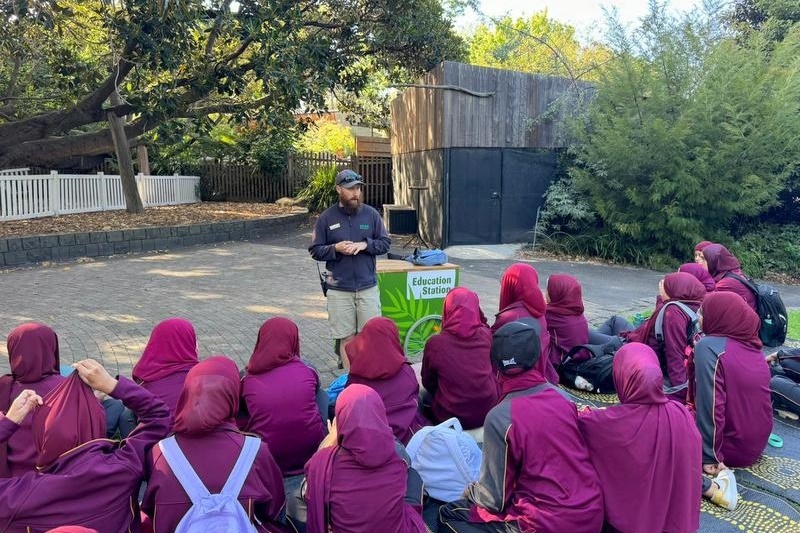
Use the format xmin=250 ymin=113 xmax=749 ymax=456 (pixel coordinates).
xmin=568 ymin=3 xmax=800 ymax=258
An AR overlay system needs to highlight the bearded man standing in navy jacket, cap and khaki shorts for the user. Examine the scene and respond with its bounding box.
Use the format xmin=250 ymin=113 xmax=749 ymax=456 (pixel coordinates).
xmin=308 ymin=169 xmax=392 ymax=368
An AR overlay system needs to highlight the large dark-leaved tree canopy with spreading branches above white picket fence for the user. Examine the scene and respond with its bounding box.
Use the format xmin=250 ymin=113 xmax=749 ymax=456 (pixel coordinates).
xmin=0 ymin=0 xmax=461 ymax=168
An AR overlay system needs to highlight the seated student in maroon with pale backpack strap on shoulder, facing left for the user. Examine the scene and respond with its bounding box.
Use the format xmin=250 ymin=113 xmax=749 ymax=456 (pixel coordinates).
xmin=622 ymin=272 xmax=706 ymax=401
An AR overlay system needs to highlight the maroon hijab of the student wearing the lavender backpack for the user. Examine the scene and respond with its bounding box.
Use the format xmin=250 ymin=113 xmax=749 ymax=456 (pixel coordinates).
xmin=173 ymin=355 xmax=240 ymax=433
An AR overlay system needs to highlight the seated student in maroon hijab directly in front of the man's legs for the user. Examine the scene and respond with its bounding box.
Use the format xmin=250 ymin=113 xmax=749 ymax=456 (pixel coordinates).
xmin=345 ymin=316 xmax=425 ymax=444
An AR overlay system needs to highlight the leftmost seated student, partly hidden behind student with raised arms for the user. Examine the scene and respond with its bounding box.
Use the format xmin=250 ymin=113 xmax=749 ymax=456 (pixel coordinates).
xmin=0 ymin=322 xmax=64 ymax=477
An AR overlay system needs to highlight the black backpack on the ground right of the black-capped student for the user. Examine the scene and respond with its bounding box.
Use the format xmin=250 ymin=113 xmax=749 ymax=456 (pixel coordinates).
xmin=558 ymin=339 xmax=622 ymax=394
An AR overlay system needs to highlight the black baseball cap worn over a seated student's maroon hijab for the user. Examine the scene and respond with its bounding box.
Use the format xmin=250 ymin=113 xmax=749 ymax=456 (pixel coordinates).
xmin=492 ymin=318 xmax=541 ymax=374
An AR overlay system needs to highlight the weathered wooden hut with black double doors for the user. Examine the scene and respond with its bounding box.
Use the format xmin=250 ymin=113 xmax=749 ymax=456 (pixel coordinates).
xmin=390 ymin=61 xmax=584 ymax=246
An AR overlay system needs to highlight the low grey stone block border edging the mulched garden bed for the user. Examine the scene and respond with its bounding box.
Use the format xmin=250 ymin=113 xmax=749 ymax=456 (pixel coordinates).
xmin=0 ymin=213 xmax=309 ymax=268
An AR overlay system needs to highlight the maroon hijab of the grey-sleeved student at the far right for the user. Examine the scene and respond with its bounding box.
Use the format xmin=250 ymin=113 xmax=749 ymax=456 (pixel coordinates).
xmin=700 ymin=292 xmax=761 ymax=350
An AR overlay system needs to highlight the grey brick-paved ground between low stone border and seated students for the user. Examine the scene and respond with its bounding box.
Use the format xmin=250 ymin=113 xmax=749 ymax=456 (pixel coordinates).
xmin=0 ymin=222 xmax=800 ymax=382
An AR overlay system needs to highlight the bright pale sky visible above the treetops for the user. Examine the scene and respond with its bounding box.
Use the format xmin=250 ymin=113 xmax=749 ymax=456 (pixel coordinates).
xmin=457 ymin=0 xmax=702 ymax=40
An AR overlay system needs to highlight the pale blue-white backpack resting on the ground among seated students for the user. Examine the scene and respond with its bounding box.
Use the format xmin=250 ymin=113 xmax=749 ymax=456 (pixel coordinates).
xmin=406 ymin=418 xmax=482 ymax=502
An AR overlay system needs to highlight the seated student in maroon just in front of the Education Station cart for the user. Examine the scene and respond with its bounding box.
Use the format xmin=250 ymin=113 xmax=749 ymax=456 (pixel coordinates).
xmin=422 ymin=287 xmax=497 ymax=429
